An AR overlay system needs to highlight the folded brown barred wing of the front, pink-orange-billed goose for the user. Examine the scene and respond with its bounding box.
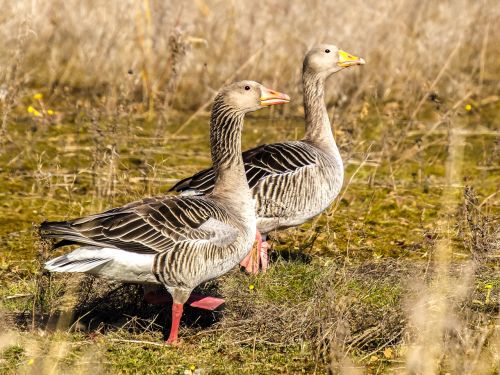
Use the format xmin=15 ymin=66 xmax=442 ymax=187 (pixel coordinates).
xmin=41 ymin=197 xmax=239 ymax=253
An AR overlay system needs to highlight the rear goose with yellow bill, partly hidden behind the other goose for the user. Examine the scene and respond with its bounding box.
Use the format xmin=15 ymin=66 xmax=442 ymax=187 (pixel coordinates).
xmin=170 ymin=44 xmax=365 ymax=273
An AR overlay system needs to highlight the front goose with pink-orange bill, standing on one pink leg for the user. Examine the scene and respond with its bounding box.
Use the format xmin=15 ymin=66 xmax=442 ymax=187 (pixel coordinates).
xmin=40 ymin=81 xmax=290 ymax=343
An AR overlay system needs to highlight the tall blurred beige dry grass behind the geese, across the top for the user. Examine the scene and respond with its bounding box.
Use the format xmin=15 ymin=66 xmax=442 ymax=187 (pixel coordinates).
xmin=0 ymin=0 xmax=500 ymax=119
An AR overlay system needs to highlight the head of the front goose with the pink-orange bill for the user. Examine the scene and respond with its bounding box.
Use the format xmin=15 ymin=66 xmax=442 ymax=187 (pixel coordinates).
xmin=218 ymin=81 xmax=290 ymax=113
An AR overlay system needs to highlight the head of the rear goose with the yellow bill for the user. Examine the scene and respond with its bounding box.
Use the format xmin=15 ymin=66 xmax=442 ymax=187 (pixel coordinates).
xmin=304 ymin=44 xmax=365 ymax=78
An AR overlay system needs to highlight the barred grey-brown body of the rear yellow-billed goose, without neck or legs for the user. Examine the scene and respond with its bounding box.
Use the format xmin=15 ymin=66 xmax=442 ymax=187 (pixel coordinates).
xmin=171 ymin=141 xmax=344 ymax=233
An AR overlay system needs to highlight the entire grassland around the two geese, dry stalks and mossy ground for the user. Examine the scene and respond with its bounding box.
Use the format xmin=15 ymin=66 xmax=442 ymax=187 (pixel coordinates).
xmin=0 ymin=0 xmax=500 ymax=374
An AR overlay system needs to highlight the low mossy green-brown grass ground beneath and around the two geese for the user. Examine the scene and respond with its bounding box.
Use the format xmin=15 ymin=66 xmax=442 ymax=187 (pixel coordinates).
xmin=0 ymin=98 xmax=500 ymax=374
